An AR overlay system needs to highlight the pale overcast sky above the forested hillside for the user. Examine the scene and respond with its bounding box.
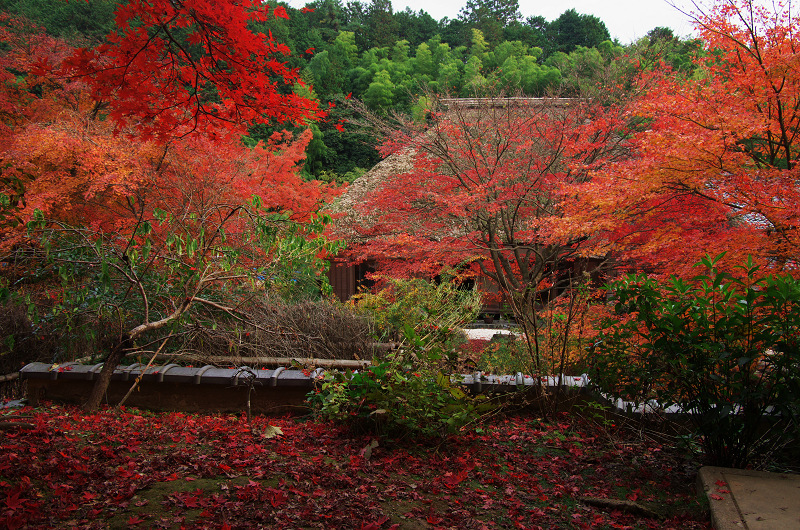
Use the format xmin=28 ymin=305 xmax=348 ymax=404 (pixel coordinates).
xmin=288 ymin=0 xmax=693 ymax=44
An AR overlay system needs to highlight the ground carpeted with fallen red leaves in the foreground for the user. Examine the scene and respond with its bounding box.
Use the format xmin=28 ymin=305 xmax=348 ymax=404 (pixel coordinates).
xmin=0 ymin=405 xmax=710 ymax=530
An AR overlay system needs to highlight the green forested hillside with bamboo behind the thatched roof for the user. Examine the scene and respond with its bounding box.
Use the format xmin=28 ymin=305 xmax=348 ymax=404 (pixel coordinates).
xmin=2 ymin=0 xmax=700 ymax=181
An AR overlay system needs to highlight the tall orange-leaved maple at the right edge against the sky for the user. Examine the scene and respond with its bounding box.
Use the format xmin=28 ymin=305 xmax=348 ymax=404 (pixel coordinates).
xmin=568 ymin=0 xmax=800 ymax=274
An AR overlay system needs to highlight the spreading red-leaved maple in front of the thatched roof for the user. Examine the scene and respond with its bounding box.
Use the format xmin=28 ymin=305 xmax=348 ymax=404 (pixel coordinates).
xmin=354 ymin=98 xmax=623 ymax=371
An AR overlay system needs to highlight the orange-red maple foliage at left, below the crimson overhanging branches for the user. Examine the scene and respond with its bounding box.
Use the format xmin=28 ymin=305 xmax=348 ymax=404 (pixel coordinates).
xmin=0 ymin=13 xmax=336 ymax=246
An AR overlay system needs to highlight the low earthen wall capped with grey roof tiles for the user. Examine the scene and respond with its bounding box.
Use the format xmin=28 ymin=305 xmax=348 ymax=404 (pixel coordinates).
xmin=20 ymin=363 xmax=588 ymax=414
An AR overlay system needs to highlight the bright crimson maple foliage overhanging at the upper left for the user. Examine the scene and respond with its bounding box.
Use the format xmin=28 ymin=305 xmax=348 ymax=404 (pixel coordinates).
xmin=63 ymin=0 xmax=319 ymax=140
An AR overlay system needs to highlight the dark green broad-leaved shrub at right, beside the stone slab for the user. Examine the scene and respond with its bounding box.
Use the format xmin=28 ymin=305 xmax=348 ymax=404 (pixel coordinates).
xmin=591 ymin=256 xmax=800 ymax=467
